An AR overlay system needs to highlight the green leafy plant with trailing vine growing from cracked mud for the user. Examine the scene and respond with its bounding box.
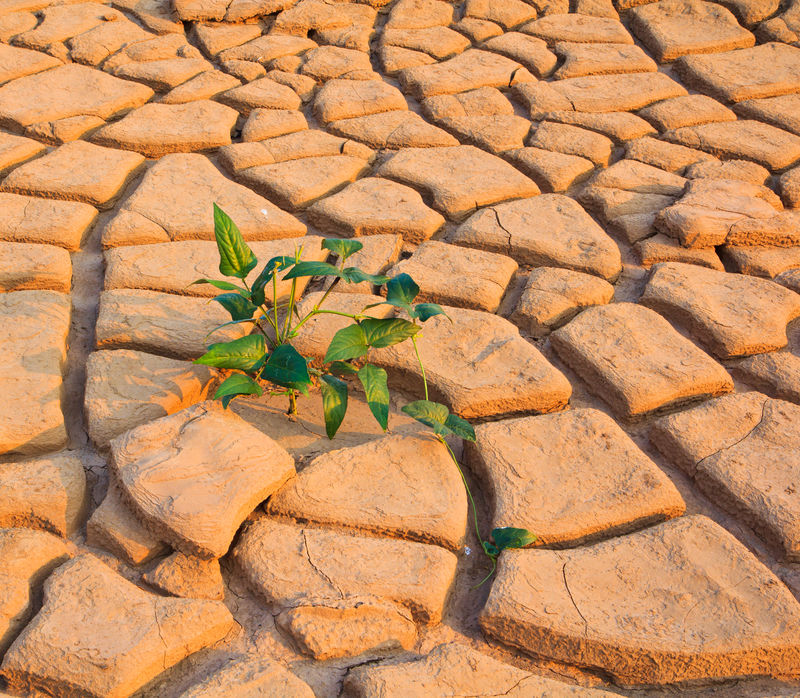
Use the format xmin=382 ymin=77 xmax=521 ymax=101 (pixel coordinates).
xmin=194 ymin=204 xmax=536 ymax=584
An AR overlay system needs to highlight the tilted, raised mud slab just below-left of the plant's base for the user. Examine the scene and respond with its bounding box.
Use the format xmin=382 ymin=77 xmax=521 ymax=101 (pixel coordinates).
xmin=111 ymin=402 xmax=294 ymax=560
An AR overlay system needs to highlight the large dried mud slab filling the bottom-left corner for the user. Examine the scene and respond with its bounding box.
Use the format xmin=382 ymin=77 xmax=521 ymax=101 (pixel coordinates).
xmin=2 ymin=555 xmax=234 ymax=698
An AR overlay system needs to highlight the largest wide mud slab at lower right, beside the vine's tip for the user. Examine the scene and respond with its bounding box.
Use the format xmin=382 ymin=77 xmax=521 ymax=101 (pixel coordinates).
xmin=480 ymin=516 xmax=800 ymax=685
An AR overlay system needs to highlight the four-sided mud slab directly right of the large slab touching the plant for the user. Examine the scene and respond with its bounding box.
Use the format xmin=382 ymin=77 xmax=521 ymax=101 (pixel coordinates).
xmin=550 ymin=300 xmax=733 ymax=420
